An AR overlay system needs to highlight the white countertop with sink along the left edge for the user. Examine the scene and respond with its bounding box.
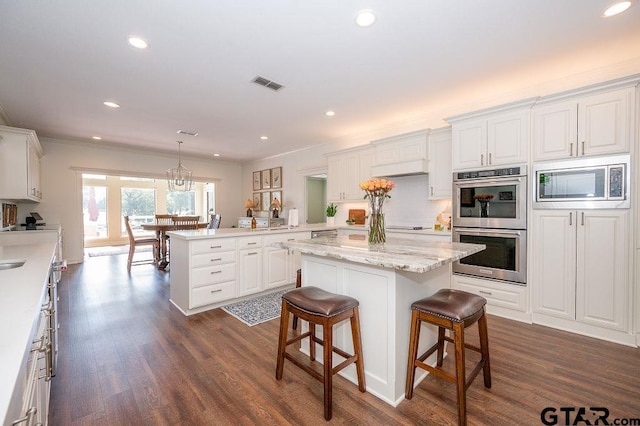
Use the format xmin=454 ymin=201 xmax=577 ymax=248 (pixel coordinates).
xmin=0 ymin=241 xmax=56 ymax=424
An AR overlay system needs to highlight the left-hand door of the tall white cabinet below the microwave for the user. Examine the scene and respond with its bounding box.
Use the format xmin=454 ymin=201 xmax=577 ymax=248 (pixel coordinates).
xmin=529 ymin=210 xmax=576 ymax=320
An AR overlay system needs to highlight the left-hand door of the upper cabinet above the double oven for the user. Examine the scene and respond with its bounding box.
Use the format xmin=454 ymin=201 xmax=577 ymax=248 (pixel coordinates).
xmin=452 ymin=119 xmax=487 ymax=170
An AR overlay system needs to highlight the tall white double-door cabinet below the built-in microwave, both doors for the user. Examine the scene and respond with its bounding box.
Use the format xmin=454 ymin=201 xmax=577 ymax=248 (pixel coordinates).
xmin=531 ymin=209 xmax=631 ymax=334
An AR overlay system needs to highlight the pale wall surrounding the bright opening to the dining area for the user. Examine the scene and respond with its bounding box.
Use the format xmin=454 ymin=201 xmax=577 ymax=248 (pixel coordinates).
xmin=18 ymin=138 xmax=244 ymax=263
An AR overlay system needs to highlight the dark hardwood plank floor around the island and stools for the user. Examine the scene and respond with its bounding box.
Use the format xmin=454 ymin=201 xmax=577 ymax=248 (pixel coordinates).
xmin=49 ymin=255 xmax=640 ymax=426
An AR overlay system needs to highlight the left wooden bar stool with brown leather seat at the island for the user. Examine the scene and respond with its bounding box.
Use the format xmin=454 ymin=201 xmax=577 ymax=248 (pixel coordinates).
xmin=276 ymin=287 xmax=366 ymax=420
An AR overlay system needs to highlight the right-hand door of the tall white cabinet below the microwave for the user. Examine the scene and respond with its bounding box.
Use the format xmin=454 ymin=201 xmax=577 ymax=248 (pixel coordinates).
xmin=576 ymin=210 xmax=630 ymax=331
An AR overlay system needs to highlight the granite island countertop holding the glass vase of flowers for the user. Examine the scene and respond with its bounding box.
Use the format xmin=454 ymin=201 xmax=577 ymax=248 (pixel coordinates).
xmin=274 ymin=235 xmax=486 ymax=273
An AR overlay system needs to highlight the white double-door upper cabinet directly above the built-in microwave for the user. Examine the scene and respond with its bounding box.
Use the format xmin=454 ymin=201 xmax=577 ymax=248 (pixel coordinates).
xmin=533 ymin=87 xmax=635 ymax=161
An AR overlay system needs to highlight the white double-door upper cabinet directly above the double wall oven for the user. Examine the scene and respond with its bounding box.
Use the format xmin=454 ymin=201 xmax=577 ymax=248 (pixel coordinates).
xmin=447 ymin=99 xmax=533 ymax=170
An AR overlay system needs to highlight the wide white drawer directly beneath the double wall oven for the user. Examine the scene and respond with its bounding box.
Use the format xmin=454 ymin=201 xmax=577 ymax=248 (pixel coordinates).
xmin=454 ymin=275 xmax=526 ymax=312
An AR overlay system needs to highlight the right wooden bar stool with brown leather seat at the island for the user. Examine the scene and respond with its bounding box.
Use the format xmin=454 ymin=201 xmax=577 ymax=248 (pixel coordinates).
xmin=405 ymin=289 xmax=491 ymax=425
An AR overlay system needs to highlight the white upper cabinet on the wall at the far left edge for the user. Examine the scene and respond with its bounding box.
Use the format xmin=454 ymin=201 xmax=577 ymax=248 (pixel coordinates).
xmin=0 ymin=126 xmax=43 ymax=201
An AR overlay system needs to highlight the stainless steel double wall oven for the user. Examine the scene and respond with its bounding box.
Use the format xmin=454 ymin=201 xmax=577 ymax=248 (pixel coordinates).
xmin=452 ymin=166 xmax=527 ymax=285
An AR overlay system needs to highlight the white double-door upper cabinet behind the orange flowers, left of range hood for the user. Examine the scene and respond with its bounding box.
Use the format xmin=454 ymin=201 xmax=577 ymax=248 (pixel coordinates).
xmin=327 ymin=146 xmax=375 ymax=203
